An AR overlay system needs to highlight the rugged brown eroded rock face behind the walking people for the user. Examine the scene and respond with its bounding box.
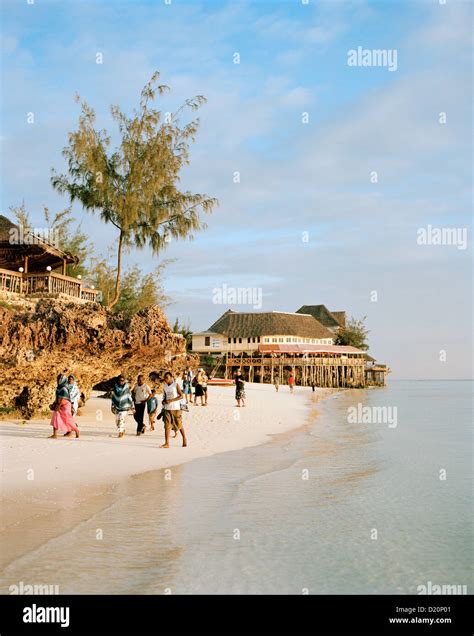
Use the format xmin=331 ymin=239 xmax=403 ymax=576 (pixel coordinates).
xmin=0 ymin=299 xmax=197 ymax=419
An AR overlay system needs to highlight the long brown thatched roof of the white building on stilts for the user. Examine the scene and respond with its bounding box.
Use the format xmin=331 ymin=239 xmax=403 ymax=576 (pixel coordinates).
xmin=208 ymin=309 xmax=333 ymax=339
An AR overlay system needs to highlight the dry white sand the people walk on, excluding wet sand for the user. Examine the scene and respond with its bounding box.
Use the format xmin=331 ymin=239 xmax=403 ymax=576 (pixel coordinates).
xmin=0 ymin=384 xmax=332 ymax=498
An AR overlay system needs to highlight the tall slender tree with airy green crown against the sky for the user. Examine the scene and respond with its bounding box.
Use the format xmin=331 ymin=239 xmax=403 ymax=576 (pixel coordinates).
xmin=51 ymin=72 xmax=218 ymax=308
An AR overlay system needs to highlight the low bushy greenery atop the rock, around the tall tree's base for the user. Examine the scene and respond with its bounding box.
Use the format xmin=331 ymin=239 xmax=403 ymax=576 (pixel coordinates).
xmin=91 ymin=260 xmax=169 ymax=315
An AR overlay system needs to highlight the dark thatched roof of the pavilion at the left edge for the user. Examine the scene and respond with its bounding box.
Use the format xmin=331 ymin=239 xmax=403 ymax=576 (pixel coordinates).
xmin=0 ymin=214 xmax=78 ymax=272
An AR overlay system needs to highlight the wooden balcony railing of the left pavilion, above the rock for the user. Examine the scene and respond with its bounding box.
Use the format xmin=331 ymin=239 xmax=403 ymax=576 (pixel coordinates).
xmin=0 ymin=269 xmax=99 ymax=302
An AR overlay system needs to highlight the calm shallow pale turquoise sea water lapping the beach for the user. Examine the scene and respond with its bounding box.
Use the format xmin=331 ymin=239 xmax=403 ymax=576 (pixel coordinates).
xmin=2 ymin=381 xmax=473 ymax=594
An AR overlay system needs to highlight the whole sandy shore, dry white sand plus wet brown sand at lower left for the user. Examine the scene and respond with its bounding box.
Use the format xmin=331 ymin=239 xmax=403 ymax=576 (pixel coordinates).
xmin=0 ymin=383 xmax=339 ymax=568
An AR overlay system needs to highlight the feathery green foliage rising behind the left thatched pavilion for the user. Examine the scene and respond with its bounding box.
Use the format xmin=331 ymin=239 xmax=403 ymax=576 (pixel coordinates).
xmin=10 ymin=202 xmax=92 ymax=276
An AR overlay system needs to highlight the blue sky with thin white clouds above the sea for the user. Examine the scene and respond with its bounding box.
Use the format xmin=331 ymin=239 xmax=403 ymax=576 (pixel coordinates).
xmin=0 ymin=0 xmax=472 ymax=379
